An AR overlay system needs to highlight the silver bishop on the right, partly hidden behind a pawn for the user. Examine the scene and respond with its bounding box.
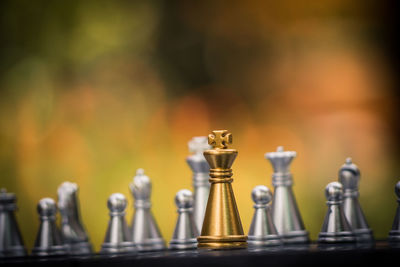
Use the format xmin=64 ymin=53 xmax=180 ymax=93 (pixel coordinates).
xmin=339 ymin=158 xmax=374 ymax=242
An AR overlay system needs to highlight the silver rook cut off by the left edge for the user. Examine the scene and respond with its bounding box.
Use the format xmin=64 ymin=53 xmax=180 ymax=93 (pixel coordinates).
xmin=0 ymin=188 xmax=27 ymax=258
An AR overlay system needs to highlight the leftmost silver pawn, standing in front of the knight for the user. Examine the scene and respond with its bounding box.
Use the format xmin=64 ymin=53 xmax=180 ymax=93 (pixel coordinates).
xmin=32 ymin=198 xmax=67 ymax=256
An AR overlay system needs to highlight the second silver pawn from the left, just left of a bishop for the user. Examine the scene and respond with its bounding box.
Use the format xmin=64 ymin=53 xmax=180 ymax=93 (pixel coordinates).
xmin=100 ymin=193 xmax=136 ymax=254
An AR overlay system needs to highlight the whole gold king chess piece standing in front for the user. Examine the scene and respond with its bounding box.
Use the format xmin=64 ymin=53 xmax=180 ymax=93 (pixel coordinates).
xmin=197 ymin=130 xmax=247 ymax=249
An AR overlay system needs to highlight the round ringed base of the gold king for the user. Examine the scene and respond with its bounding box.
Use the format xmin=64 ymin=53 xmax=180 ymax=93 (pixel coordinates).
xmin=197 ymin=235 xmax=247 ymax=249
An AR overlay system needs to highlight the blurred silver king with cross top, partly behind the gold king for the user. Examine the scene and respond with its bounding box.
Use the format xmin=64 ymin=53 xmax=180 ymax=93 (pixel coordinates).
xmin=186 ymin=136 xmax=211 ymax=232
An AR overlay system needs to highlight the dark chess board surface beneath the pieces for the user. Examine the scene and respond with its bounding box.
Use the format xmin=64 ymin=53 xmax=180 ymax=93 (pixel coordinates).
xmin=0 ymin=241 xmax=400 ymax=267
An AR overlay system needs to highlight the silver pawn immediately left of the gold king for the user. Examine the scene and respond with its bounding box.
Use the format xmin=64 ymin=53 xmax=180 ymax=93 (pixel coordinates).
xmin=169 ymin=189 xmax=199 ymax=249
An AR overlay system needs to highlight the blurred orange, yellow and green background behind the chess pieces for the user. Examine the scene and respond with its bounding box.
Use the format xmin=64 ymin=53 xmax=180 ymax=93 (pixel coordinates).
xmin=0 ymin=0 xmax=400 ymax=250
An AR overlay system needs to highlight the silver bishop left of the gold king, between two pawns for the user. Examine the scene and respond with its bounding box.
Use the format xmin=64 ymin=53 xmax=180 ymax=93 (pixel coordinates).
xmin=130 ymin=169 xmax=166 ymax=251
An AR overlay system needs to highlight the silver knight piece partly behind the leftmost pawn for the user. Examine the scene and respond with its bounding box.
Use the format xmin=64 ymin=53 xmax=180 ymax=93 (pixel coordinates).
xmin=57 ymin=182 xmax=92 ymax=255
